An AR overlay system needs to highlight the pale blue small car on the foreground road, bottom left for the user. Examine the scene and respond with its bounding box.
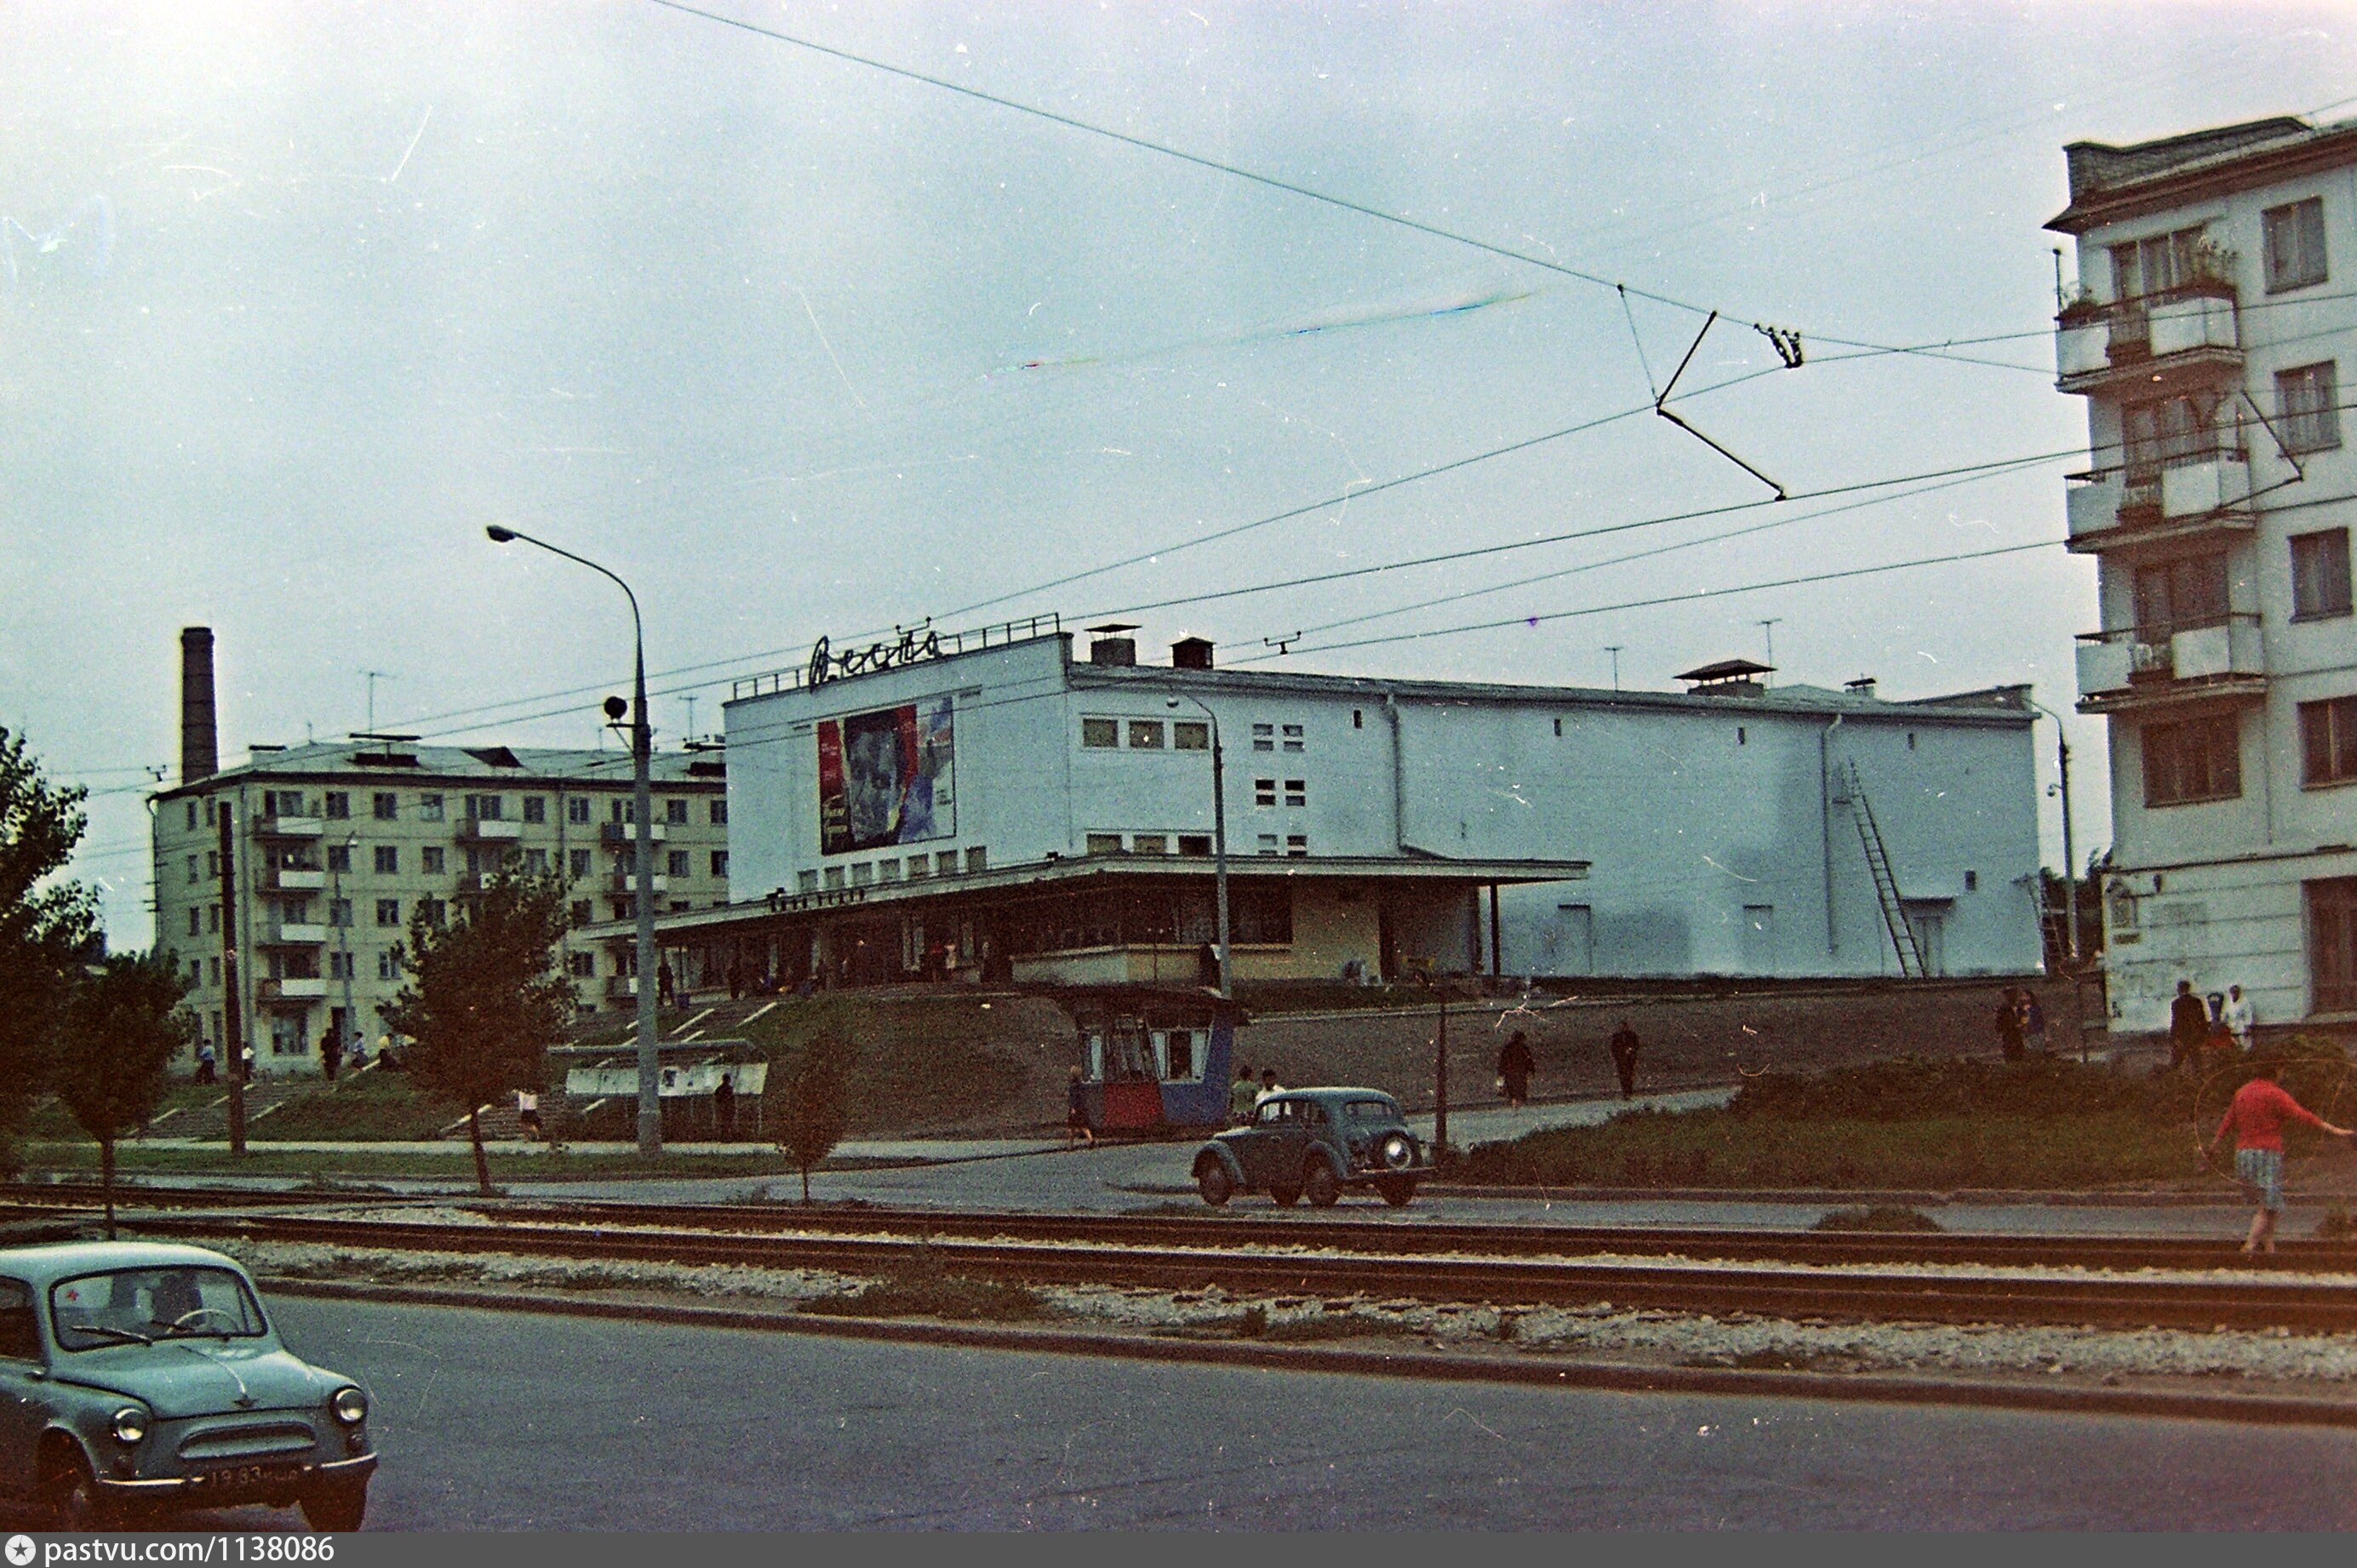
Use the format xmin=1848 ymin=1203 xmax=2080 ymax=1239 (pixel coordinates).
xmin=0 ymin=1243 xmax=377 ymax=1531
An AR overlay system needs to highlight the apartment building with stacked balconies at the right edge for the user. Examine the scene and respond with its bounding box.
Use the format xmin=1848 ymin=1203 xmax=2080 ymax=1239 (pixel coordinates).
xmin=2048 ymin=117 xmax=2357 ymax=1030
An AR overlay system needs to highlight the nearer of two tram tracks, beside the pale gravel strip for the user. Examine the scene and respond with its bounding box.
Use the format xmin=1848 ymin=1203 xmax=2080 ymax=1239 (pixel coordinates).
xmin=96 ymin=1215 xmax=2357 ymax=1332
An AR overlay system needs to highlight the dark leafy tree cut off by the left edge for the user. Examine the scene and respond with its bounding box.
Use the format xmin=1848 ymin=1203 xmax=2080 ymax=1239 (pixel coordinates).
xmin=0 ymin=729 xmax=99 ymax=1167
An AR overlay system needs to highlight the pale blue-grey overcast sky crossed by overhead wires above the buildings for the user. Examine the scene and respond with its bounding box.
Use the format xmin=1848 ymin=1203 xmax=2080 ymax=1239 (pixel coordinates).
xmin=0 ymin=0 xmax=2357 ymax=946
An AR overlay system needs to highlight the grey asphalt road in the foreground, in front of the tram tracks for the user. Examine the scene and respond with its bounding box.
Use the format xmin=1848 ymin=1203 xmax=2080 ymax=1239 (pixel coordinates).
xmin=152 ymin=1299 xmax=2357 ymax=1531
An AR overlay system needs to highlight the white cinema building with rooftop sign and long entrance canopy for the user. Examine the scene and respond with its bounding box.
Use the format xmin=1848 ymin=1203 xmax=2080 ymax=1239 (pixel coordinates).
xmin=636 ymin=622 xmax=2041 ymax=983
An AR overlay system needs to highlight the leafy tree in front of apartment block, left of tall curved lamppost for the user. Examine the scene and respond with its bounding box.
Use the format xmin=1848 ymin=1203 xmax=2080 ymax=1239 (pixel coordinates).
xmin=384 ymin=867 xmax=573 ymax=1198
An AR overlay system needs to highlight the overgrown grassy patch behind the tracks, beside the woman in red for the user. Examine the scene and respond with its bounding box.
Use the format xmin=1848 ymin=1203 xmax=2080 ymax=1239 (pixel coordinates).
xmin=1462 ymin=1042 xmax=2357 ymax=1193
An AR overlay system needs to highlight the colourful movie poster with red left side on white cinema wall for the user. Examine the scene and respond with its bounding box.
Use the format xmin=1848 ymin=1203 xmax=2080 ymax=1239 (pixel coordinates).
xmin=818 ymin=698 xmax=957 ymax=856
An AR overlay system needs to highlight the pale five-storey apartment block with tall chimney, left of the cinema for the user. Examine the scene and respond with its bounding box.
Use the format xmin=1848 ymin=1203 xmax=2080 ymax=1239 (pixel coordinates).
xmin=153 ymin=634 xmax=729 ymax=1073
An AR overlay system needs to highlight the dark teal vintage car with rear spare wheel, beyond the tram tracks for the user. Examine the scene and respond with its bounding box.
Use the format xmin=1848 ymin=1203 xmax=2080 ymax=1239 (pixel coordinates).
xmin=1195 ymin=1090 xmax=1433 ymax=1207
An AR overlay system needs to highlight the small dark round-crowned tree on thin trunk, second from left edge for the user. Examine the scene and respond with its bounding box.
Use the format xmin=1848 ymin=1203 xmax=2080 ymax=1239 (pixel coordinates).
xmin=49 ymin=953 xmax=196 ymax=1240
